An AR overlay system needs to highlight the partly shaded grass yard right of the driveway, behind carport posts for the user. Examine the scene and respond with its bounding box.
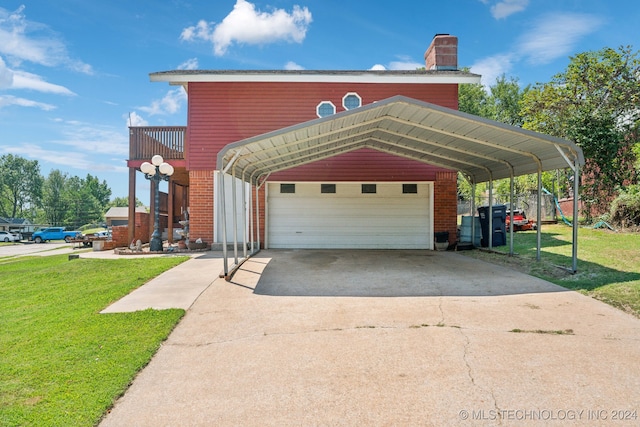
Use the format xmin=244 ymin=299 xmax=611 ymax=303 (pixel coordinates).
xmin=459 ymin=224 xmax=640 ymax=317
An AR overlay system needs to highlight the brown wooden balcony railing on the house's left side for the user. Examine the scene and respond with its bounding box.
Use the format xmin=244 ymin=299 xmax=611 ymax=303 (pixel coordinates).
xmin=129 ymin=126 xmax=187 ymax=161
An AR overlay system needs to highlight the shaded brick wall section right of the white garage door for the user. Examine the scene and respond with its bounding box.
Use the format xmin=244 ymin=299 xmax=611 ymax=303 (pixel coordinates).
xmin=433 ymin=172 xmax=458 ymax=243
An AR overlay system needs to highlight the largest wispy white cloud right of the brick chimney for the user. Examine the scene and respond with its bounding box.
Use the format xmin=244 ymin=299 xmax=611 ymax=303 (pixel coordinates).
xmin=518 ymin=13 xmax=602 ymax=64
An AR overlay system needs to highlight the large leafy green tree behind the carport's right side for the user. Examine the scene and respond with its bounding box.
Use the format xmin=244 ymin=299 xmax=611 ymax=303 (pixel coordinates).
xmin=522 ymin=47 xmax=640 ymax=221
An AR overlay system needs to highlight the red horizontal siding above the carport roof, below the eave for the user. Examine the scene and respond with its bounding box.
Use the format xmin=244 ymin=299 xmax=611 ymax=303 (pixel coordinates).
xmin=186 ymin=82 xmax=458 ymax=170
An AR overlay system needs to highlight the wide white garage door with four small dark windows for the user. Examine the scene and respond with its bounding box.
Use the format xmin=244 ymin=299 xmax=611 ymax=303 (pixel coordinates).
xmin=267 ymin=182 xmax=433 ymax=249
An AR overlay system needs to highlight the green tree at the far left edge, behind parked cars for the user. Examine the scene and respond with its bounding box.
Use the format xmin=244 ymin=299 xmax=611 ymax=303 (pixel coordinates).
xmin=0 ymin=154 xmax=43 ymax=218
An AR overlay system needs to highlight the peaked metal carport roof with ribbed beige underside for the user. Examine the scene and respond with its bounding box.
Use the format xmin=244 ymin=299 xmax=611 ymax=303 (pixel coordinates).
xmin=217 ymin=96 xmax=584 ymax=183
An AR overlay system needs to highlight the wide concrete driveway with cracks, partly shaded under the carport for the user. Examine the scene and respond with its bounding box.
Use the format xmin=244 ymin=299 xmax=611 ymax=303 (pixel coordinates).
xmin=102 ymin=250 xmax=640 ymax=426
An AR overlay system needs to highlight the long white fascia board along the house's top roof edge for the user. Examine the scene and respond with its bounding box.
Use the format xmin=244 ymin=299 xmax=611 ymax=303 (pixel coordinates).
xmin=150 ymin=73 xmax=480 ymax=86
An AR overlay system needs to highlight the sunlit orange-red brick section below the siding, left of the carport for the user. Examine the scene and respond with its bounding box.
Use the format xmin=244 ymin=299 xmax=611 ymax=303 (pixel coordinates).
xmin=189 ymin=170 xmax=214 ymax=243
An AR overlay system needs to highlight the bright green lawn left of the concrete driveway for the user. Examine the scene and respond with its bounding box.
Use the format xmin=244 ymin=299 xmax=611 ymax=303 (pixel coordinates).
xmin=0 ymin=255 xmax=188 ymax=426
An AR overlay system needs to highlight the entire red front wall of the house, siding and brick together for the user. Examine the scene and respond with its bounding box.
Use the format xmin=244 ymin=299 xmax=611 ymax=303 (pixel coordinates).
xmin=185 ymin=82 xmax=458 ymax=243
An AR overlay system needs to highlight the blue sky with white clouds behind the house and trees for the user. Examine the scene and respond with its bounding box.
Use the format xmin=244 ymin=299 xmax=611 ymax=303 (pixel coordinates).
xmin=0 ymin=0 xmax=640 ymax=203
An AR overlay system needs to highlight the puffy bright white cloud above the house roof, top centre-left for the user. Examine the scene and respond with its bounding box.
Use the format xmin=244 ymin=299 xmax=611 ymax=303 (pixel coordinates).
xmin=180 ymin=0 xmax=312 ymax=56
